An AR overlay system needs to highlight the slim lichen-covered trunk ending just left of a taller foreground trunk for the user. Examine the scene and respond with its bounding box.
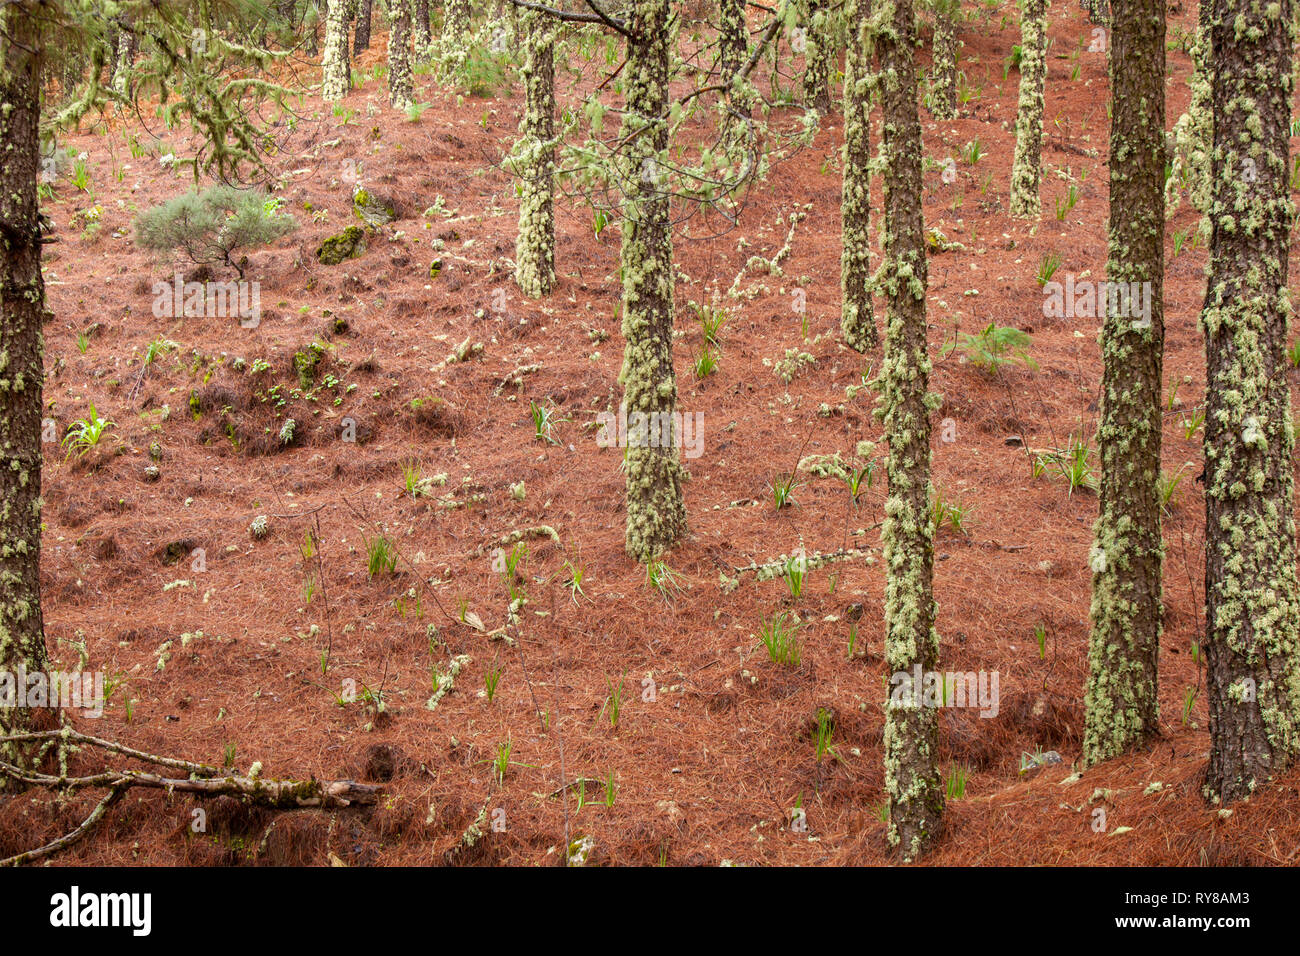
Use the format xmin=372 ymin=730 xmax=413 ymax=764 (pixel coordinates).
xmin=840 ymin=0 xmax=879 ymax=352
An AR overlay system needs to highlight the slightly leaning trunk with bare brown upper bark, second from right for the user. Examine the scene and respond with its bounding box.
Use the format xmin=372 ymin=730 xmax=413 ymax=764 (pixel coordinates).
xmin=1083 ymin=0 xmax=1165 ymax=765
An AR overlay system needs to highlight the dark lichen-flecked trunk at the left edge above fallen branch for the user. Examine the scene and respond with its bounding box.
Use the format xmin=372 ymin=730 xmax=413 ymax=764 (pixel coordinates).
xmin=0 ymin=3 xmax=52 ymax=780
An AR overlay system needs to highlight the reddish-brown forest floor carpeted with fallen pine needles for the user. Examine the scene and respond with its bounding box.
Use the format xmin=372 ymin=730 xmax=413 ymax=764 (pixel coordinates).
xmin=0 ymin=4 xmax=1300 ymax=865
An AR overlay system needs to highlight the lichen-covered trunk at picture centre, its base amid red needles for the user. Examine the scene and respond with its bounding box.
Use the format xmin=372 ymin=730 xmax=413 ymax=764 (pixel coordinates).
xmin=619 ymin=0 xmax=686 ymax=563
